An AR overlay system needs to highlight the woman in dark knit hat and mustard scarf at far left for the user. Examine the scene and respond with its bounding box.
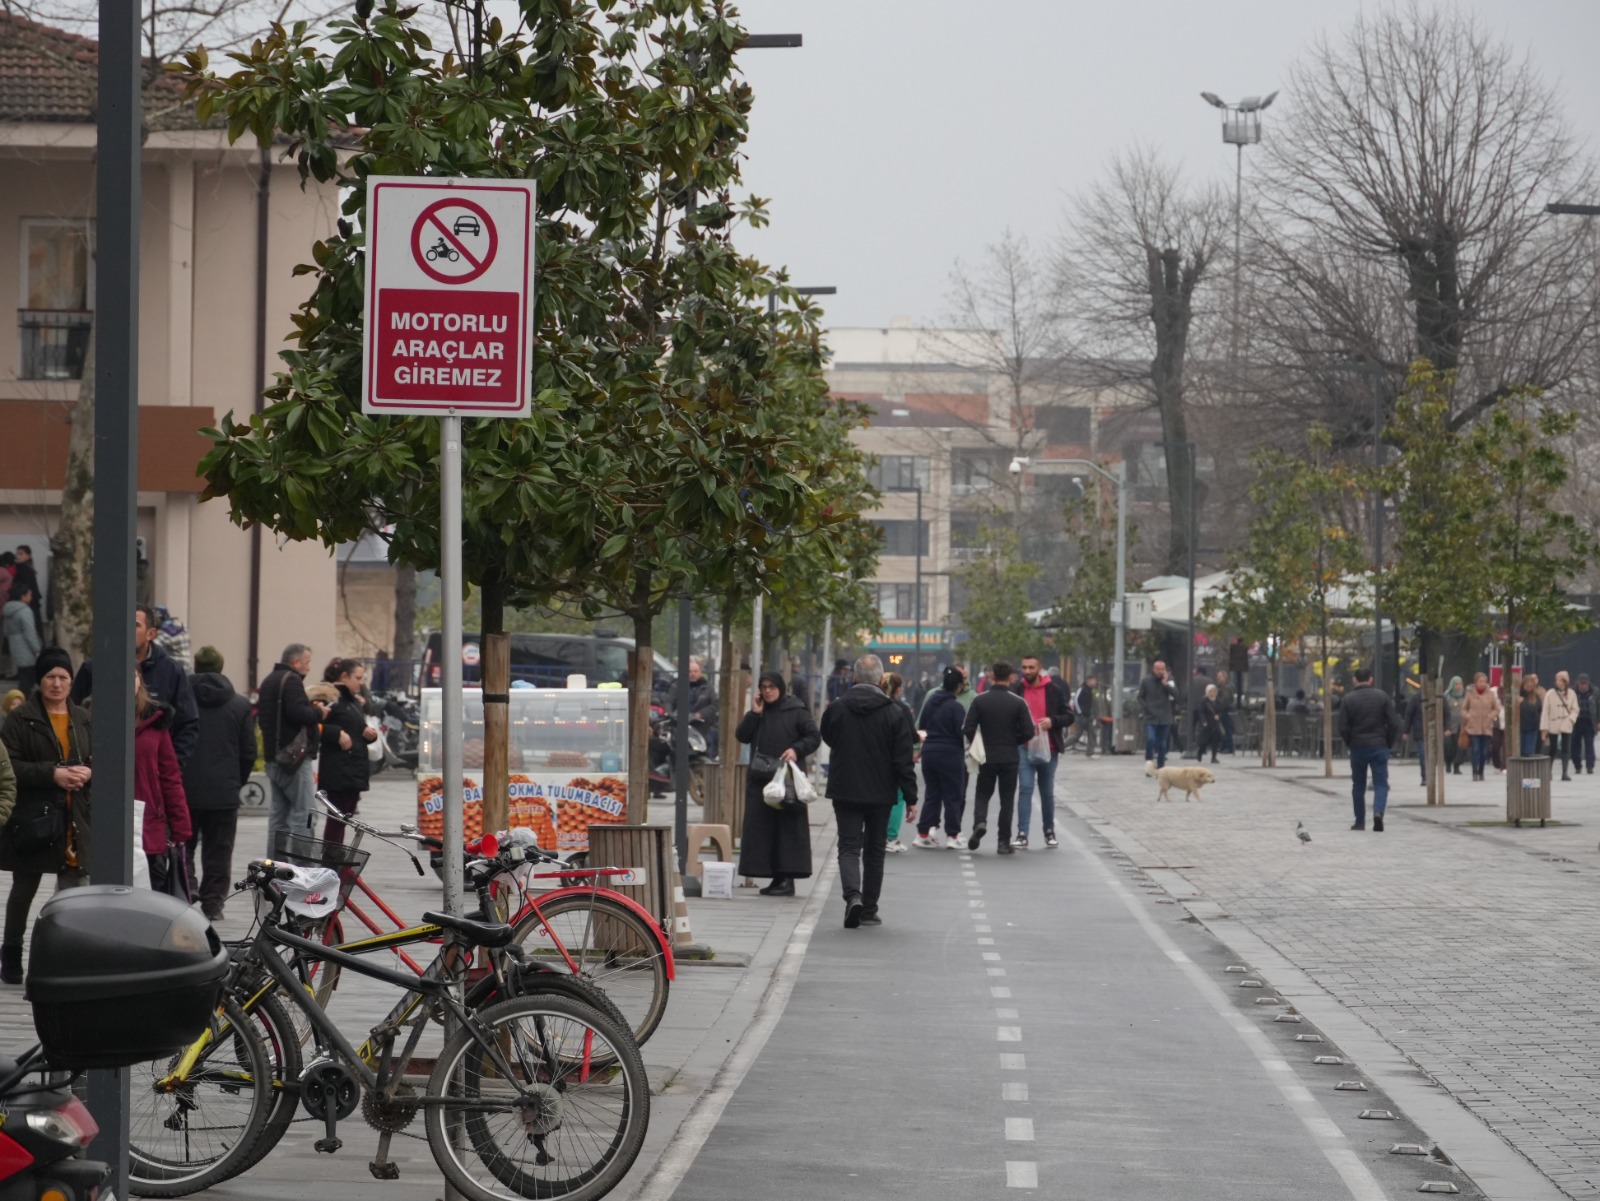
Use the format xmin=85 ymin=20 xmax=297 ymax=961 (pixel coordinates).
xmin=0 ymin=646 xmax=94 ymax=984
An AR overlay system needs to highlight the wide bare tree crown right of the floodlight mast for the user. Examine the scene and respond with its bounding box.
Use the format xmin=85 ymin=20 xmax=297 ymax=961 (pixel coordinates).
xmin=1251 ymin=0 xmax=1594 ymax=427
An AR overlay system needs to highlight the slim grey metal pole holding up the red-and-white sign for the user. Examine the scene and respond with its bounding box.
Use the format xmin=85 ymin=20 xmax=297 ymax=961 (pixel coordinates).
xmin=438 ymin=414 xmax=464 ymax=915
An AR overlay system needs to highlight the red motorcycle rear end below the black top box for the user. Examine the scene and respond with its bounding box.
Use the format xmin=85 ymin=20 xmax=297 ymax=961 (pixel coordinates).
xmin=0 ymin=1047 xmax=115 ymax=1201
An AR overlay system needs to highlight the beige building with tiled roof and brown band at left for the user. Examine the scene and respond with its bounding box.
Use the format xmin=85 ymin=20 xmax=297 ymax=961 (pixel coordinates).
xmin=0 ymin=13 xmax=338 ymax=688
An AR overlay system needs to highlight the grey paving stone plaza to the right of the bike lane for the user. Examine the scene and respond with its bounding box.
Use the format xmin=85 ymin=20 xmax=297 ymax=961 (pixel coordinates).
xmin=1056 ymin=755 xmax=1600 ymax=1198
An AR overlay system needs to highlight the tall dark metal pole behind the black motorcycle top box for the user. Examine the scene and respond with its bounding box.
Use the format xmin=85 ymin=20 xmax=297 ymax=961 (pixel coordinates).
xmin=90 ymin=3 xmax=144 ymax=1198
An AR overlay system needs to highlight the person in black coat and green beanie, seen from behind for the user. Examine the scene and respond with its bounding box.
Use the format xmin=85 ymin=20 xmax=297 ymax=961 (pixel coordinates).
xmin=184 ymin=646 xmax=256 ymax=921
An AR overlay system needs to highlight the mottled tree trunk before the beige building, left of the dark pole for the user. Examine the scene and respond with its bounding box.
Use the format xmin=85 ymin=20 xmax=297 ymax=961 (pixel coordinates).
xmin=50 ymin=328 xmax=94 ymax=664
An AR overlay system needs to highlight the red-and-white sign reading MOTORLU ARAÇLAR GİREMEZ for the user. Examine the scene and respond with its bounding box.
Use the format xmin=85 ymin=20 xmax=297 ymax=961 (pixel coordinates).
xmin=362 ymin=176 xmax=534 ymax=417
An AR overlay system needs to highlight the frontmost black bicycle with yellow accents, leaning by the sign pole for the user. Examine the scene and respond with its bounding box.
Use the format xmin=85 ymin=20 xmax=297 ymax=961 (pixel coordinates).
xmin=136 ymin=860 xmax=650 ymax=1201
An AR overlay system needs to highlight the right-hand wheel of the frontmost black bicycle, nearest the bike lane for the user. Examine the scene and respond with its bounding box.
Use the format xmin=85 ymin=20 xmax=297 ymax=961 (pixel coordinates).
xmin=427 ymin=996 xmax=650 ymax=1201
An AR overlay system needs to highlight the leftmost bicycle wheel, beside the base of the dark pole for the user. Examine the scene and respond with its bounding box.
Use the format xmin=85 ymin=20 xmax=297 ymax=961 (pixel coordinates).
xmin=128 ymin=998 xmax=272 ymax=1196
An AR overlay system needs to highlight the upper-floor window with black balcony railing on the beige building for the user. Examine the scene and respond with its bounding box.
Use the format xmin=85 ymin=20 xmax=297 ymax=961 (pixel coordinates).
xmin=16 ymin=219 xmax=94 ymax=379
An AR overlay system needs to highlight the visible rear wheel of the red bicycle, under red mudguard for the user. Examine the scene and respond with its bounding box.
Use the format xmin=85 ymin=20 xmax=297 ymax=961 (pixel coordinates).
xmin=512 ymin=894 xmax=672 ymax=1046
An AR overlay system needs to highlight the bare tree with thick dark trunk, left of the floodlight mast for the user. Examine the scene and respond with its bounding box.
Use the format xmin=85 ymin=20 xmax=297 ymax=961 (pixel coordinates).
xmin=1056 ymin=149 xmax=1229 ymax=573
